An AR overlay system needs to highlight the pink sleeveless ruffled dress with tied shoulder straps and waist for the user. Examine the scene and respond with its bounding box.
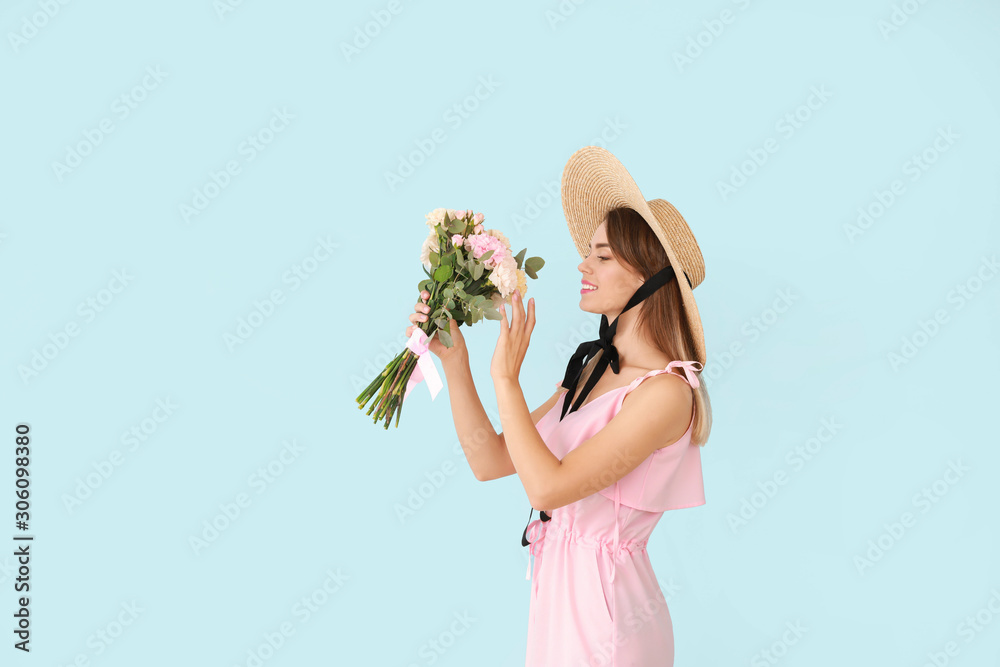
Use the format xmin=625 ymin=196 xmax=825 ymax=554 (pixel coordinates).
xmin=525 ymin=361 xmax=705 ymax=667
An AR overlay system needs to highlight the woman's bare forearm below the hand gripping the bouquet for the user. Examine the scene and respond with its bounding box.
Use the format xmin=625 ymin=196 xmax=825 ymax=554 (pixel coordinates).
xmin=442 ymin=358 xmax=504 ymax=481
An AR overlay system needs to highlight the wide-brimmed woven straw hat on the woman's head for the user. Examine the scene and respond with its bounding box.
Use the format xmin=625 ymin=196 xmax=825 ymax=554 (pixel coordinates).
xmin=562 ymin=146 xmax=707 ymax=365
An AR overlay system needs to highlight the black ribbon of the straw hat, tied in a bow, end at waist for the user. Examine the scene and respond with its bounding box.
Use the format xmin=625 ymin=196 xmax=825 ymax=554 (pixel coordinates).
xmin=521 ymin=266 xmax=694 ymax=547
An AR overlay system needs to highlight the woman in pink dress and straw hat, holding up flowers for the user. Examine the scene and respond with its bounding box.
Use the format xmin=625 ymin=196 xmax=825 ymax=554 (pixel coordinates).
xmin=407 ymin=146 xmax=711 ymax=667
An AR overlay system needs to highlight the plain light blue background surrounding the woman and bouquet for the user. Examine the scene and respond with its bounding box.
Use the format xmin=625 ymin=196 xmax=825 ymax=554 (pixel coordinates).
xmin=0 ymin=0 xmax=1000 ymax=667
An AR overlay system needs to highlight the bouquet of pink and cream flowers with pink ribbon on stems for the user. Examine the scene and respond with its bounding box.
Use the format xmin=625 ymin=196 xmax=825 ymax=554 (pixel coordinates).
xmin=357 ymin=208 xmax=545 ymax=429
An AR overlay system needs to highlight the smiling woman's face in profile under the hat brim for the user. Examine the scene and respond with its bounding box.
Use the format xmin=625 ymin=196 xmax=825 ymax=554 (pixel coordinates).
xmin=577 ymin=222 xmax=643 ymax=320
